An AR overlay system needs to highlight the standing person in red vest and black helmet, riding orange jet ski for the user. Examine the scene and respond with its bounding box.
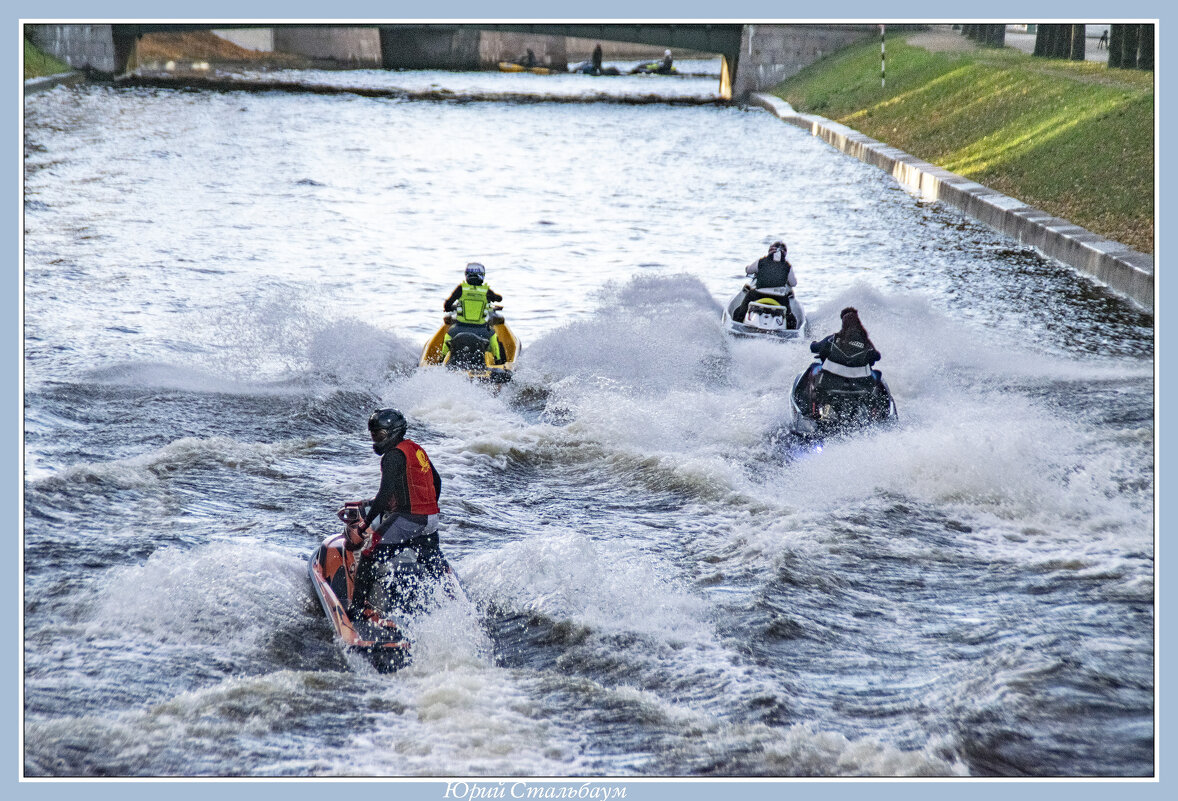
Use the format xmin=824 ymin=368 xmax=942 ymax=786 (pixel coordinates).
xmin=348 ymin=409 xmax=445 ymax=620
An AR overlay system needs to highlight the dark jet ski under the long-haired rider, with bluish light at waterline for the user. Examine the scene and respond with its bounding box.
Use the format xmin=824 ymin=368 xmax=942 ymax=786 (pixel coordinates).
xmin=789 ymin=362 xmax=898 ymax=444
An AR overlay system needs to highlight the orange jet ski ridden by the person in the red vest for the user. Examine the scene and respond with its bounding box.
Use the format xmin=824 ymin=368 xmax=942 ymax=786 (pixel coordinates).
xmin=310 ymin=501 xmax=462 ymax=673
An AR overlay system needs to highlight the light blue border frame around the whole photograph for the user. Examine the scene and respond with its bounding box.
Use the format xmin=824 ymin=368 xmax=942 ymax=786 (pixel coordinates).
xmin=11 ymin=0 xmax=1178 ymax=801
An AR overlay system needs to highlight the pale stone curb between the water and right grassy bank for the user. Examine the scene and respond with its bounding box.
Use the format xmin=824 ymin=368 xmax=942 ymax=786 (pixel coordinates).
xmin=749 ymin=94 xmax=1154 ymax=312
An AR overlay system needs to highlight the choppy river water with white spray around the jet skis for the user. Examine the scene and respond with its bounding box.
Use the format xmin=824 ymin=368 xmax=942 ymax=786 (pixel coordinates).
xmin=22 ymin=62 xmax=1156 ymax=777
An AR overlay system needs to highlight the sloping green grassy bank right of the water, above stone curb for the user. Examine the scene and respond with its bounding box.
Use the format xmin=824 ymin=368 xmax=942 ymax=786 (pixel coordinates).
xmin=774 ymin=37 xmax=1153 ymax=253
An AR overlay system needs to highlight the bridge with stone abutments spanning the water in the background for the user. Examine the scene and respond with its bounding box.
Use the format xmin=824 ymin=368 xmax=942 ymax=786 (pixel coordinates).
xmin=26 ymin=21 xmax=874 ymax=100
